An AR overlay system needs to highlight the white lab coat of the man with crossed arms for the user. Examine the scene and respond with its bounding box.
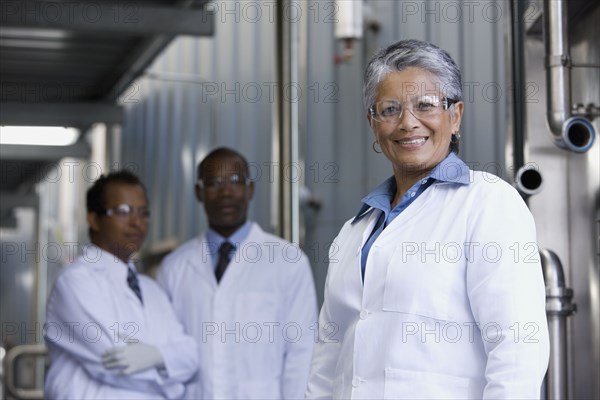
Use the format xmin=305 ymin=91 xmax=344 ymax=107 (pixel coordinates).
xmin=44 ymin=246 xmax=198 ymax=399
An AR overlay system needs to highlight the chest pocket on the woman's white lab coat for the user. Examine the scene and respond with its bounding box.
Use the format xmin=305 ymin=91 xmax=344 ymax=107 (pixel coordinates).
xmin=383 ymin=246 xmax=457 ymax=320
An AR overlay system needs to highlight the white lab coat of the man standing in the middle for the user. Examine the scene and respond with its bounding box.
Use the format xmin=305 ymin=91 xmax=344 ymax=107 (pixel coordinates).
xmin=157 ymin=223 xmax=317 ymax=399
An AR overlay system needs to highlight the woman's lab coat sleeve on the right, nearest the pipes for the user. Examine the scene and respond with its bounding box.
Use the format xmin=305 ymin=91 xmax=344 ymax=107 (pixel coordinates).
xmin=465 ymin=181 xmax=549 ymax=399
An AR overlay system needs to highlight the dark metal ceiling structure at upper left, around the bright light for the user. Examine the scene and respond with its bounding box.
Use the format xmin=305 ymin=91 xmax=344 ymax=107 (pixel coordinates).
xmin=0 ymin=0 xmax=214 ymax=225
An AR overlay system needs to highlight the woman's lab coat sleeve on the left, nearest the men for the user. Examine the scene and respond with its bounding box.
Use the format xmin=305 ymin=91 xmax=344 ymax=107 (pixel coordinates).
xmin=305 ymin=238 xmax=342 ymax=399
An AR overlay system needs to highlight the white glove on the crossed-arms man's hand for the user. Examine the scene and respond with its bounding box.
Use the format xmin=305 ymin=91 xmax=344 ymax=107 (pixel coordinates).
xmin=102 ymin=342 xmax=164 ymax=375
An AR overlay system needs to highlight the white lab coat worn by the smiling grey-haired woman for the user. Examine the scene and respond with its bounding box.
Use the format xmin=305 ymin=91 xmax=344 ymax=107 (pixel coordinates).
xmin=307 ymin=171 xmax=549 ymax=399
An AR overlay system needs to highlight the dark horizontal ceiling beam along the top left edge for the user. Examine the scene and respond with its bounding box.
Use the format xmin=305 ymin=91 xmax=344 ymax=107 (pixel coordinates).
xmin=0 ymin=0 xmax=215 ymax=36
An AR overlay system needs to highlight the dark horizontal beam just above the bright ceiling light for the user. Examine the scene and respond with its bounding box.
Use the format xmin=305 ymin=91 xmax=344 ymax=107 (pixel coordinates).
xmin=0 ymin=102 xmax=124 ymax=127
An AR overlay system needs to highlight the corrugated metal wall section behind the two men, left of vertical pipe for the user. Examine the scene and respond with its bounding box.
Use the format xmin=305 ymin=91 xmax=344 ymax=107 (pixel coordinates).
xmin=121 ymin=20 xmax=274 ymax=245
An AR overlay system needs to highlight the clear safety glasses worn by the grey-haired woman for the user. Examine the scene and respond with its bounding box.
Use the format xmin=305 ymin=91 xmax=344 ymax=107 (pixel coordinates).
xmin=369 ymin=95 xmax=458 ymax=123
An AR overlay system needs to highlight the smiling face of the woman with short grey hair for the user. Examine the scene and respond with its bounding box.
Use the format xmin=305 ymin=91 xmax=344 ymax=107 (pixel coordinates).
xmin=368 ymin=67 xmax=464 ymax=178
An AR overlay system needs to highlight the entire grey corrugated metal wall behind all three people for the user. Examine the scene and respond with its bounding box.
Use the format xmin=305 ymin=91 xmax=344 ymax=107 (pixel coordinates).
xmin=121 ymin=0 xmax=510 ymax=302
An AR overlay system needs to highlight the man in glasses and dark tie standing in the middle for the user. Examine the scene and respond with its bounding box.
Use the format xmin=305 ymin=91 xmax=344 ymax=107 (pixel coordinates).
xmin=157 ymin=148 xmax=317 ymax=399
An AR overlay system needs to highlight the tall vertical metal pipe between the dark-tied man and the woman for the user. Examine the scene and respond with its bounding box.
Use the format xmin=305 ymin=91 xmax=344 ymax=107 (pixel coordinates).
xmin=273 ymin=0 xmax=301 ymax=243
